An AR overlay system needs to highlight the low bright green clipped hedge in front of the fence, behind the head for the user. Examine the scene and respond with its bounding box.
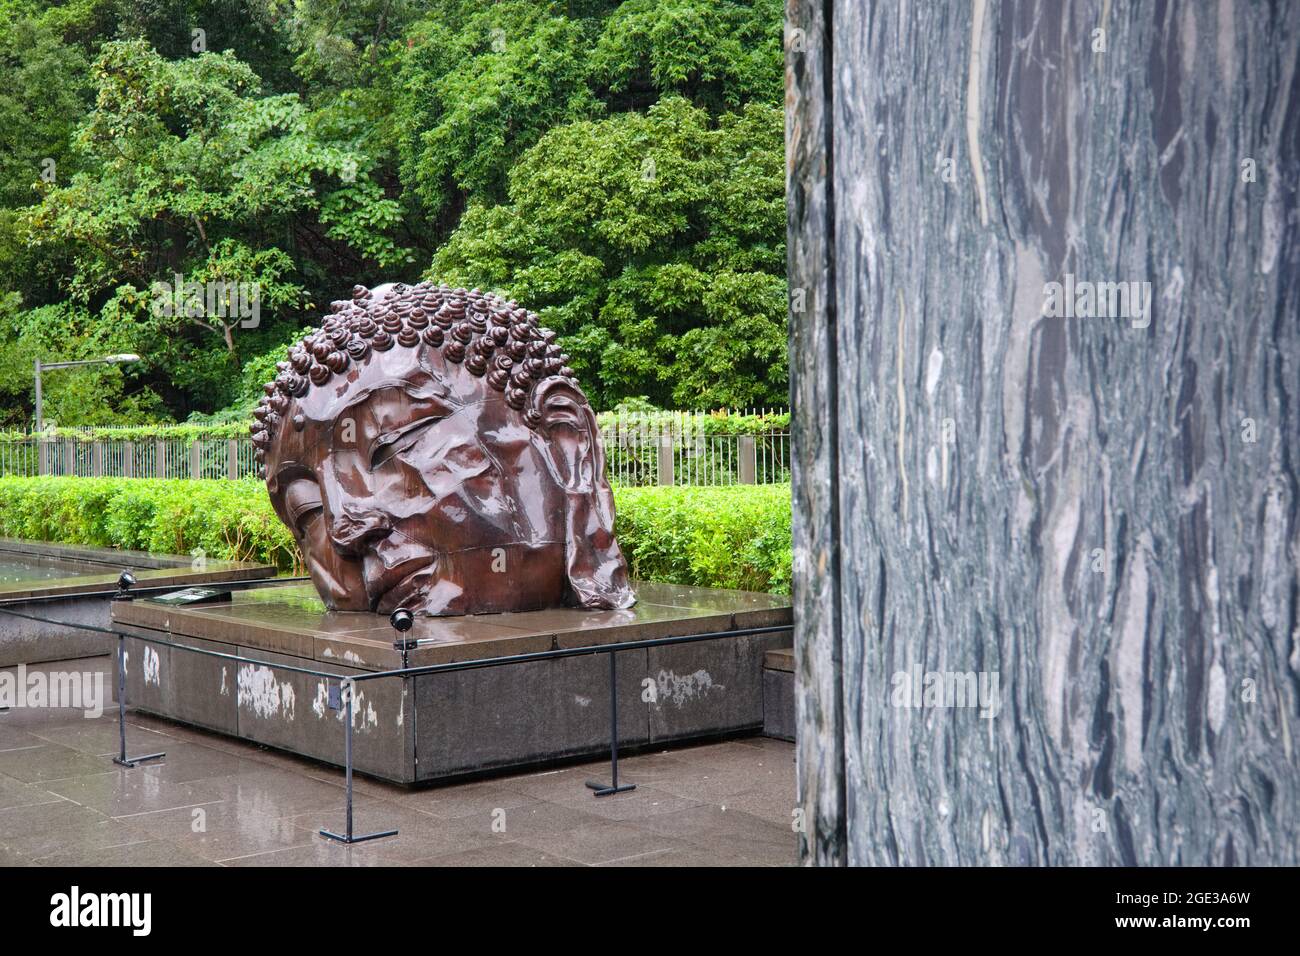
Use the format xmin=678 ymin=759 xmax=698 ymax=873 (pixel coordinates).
xmin=0 ymin=477 xmax=790 ymax=593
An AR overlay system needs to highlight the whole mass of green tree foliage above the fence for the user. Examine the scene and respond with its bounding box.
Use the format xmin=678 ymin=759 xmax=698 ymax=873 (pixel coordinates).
xmin=0 ymin=0 xmax=787 ymax=425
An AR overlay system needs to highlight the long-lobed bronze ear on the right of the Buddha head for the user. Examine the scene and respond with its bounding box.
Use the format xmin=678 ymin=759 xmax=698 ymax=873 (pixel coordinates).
xmin=525 ymin=376 xmax=636 ymax=607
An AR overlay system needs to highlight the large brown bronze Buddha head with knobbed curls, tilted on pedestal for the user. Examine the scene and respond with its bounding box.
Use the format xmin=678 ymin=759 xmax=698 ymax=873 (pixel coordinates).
xmin=252 ymin=282 xmax=634 ymax=614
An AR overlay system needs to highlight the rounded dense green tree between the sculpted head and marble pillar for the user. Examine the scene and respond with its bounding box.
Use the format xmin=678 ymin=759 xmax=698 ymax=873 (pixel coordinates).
xmin=430 ymin=98 xmax=785 ymax=407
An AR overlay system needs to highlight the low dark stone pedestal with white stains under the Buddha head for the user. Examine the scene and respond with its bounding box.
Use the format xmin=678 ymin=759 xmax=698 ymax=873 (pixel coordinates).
xmin=114 ymin=584 xmax=792 ymax=783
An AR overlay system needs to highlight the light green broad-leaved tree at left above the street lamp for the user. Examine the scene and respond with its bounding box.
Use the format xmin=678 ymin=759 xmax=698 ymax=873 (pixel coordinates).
xmin=19 ymin=40 xmax=407 ymax=411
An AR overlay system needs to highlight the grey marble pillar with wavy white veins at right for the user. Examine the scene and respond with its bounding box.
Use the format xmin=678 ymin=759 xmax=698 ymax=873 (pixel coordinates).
xmin=787 ymin=0 xmax=1300 ymax=865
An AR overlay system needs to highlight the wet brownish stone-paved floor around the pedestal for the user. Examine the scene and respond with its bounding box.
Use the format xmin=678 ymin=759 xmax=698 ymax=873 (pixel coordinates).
xmin=0 ymin=658 xmax=796 ymax=866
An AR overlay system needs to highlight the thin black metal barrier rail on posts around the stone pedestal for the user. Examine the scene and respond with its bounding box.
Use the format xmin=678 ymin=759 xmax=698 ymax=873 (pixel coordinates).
xmin=0 ymin=571 xmax=790 ymax=845
